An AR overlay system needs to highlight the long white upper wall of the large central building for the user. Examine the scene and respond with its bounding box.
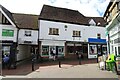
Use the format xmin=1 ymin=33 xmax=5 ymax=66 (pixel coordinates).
xmin=39 ymin=20 xmax=106 ymax=42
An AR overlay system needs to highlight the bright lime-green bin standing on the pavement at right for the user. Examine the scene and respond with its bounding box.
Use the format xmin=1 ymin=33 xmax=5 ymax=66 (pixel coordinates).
xmin=106 ymin=54 xmax=116 ymax=71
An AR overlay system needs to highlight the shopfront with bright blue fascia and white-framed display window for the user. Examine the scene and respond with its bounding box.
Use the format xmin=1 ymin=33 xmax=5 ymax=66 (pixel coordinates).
xmin=88 ymin=38 xmax=107 ymax=58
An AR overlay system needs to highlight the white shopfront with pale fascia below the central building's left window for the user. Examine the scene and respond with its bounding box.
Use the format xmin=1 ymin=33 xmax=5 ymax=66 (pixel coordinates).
xmin=41 ymin=40 xmax=66 ymax=58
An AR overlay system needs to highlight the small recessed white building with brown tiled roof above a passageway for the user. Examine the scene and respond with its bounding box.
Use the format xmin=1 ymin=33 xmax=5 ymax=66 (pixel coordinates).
xmin=12 ymin=13 xmax=38 ymax=61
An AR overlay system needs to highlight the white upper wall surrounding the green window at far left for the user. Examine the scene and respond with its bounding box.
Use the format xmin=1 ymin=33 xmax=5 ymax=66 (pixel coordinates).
xmin=0 ymin=24 xmax=17 ymax=42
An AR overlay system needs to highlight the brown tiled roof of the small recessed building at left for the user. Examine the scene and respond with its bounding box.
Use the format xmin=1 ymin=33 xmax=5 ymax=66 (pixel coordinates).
xmin=12 ymin=13 xmax=38 ymax=29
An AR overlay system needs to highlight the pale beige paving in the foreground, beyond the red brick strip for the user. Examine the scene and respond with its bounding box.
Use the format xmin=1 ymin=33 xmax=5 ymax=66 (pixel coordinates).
xmin=26 ymin=64 xmax=118 ymax=78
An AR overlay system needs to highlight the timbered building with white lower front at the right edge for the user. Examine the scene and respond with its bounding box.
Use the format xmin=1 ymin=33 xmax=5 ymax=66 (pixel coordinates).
xmin=104 ymin=0 xmax=120 ymax=55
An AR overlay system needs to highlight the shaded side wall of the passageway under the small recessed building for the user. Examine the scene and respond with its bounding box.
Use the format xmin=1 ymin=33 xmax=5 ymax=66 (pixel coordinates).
xmin=17 ymin=45 xmax=31 ymax=61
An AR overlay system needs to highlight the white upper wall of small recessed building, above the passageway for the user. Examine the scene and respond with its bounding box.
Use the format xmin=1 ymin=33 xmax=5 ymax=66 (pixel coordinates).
xmin=18 ymin=29 xmax=38 ymax=45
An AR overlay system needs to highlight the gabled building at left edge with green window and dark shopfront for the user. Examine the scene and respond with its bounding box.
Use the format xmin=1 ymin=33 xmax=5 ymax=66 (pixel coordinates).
xmin=0 ymin=5 xmax=18 ymax=60
